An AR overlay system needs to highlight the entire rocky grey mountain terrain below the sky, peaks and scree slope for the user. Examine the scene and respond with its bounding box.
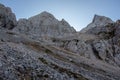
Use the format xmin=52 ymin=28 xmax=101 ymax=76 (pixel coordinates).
xmin=0 ymin=4 xmax=120 ymax=80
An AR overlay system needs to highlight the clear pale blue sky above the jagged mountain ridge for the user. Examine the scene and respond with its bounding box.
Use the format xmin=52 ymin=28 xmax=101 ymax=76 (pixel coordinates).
xmin=0 ymin=0 xmax=120 ymax=31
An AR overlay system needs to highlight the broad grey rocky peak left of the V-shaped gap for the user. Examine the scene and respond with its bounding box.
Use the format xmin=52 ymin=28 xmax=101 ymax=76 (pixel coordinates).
xmin=14 ymin=12 xmax=76 ymax=38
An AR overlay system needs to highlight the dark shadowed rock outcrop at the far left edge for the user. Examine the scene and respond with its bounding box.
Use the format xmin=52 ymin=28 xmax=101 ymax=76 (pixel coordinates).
xmin=0 ymin=4 xmax=16 ymax=29
